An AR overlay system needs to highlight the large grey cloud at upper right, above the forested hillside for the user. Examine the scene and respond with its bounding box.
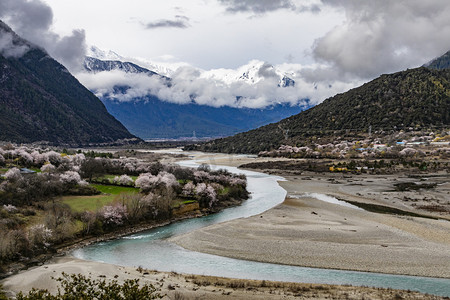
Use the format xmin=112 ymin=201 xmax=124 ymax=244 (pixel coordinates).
xmin=310 ymin=0 xmax=450 ymax=79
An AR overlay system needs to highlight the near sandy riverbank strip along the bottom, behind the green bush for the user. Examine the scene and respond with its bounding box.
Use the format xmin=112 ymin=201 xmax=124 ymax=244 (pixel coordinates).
xmin=2 ymin=257 xmax=445 ymax=300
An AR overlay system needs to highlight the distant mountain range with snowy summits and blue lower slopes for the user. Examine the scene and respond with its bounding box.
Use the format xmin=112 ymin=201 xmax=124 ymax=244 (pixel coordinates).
xmin=79 ymin=49 xmax=305 ymax=139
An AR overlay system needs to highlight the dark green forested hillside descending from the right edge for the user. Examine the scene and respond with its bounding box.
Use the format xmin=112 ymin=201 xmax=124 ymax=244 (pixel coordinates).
xmin=190 ymin=67 xmax=450 ymax=153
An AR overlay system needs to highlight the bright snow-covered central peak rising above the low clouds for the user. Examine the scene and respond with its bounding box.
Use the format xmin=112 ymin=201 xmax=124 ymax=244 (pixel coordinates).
xmin=200 ymin=60 xmax=295 ymax=87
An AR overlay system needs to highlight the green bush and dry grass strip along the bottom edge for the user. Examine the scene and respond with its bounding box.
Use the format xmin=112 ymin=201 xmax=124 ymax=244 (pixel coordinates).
xmin=0 ymin=268 xmax=442 ymax=300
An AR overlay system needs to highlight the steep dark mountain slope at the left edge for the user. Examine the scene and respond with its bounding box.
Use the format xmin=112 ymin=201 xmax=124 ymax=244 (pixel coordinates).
xmin=0 ymin=21 xmax=134 ymax=145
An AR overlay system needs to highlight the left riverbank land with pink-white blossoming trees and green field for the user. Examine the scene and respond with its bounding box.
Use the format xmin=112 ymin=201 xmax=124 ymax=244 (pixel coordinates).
xmin=0 ymin=144 xmax=248 ymax=272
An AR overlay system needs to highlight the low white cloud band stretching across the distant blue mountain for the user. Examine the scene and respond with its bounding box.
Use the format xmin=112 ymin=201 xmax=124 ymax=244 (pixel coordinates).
xmin=76 ymin=61 xmax=355 ymax=108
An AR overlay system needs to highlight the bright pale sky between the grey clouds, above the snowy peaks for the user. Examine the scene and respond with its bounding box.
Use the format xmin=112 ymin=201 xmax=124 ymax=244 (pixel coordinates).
xmin=45 ymin=0 xmax=344 ymax=69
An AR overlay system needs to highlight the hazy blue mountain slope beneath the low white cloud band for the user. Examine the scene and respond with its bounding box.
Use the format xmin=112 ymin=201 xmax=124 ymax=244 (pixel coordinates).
xmin=102 ymin=96 xmax=302 ymax=139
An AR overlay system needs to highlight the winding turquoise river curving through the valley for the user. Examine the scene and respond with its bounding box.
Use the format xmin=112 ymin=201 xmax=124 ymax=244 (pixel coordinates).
xmin=72 ymin=155 xmax=450 ymax=296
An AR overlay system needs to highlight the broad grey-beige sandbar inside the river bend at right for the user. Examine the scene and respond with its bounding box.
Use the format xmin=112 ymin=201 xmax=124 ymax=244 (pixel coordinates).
xmin=172 ymin=157 xmax=450 ymax=278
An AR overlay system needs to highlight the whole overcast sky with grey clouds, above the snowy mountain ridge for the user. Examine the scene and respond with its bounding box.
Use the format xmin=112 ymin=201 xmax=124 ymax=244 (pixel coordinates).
xmin=0 ymin=0 xmax=450 ymax=108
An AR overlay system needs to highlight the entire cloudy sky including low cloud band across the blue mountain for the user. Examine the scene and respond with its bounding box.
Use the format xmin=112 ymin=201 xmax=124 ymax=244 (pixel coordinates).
xmin=0 ymin=0 xmax=450 ymax=107
